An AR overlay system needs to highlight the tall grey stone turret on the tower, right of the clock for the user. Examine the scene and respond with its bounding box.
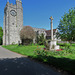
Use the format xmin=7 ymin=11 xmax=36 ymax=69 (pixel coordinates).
xmin=16 ymin=0 xmax=23 ymax=30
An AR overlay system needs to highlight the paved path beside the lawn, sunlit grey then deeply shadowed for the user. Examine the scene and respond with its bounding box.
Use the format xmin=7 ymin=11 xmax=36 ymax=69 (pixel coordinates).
xmin=0 ymin=46 xmax=61 ymax=75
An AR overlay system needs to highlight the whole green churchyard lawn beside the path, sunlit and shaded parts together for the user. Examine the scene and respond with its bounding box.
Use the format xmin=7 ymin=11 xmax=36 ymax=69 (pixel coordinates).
xmin=2 ymin=44 xmax=75 ymax=74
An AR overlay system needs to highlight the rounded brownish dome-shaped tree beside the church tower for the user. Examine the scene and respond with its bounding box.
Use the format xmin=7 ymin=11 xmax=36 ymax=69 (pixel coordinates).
xmin=20 ymin=26 xmax=35 ymax=45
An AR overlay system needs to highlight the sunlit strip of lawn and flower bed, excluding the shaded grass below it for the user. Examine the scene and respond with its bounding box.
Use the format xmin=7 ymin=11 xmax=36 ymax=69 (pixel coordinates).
xmin=3 ymin=44 xmax=75 ymax=56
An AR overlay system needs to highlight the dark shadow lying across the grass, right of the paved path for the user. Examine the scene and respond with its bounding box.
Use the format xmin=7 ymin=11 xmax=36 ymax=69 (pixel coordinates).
xmin=29 ymin=55 xmax=75 ymax=75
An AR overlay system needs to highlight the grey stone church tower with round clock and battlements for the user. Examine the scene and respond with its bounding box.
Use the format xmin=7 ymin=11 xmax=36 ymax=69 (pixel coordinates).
xmin=3 ymin=0 xmax=23 ymax=45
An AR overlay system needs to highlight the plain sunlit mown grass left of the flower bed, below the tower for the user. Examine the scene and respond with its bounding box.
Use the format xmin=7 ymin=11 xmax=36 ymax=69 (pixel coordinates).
xmin=2 ymin=45 xmax=44 ymax=56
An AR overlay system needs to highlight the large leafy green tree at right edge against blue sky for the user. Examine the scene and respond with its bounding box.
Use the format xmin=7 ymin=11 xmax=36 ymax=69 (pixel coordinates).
xmin=58 ymin=8 xmax=75 ymax=41
